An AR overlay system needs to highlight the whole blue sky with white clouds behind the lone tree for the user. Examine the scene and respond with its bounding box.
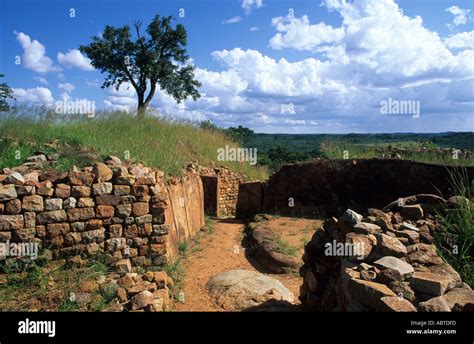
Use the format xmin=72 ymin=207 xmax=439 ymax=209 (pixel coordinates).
xmin=0 ymin=0 xmax=474 ymax=133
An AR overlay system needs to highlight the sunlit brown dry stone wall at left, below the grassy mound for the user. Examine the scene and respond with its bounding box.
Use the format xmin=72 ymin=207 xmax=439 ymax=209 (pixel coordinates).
xmin=0 ymin=157 xmax=204 ymax=271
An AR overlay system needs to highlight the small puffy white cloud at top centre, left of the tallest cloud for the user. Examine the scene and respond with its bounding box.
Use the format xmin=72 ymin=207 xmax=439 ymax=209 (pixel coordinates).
xmin=270 ymin=14 xmax=344 ymax=50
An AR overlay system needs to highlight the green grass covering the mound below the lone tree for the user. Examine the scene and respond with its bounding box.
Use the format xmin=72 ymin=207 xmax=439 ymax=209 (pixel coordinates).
xmin=0 ymin=109 xmax=268 ymax=179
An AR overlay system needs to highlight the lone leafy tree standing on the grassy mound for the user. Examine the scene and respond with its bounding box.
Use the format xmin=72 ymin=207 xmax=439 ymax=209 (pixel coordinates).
xmin=79 ymin=15 xmax=201 ymax=117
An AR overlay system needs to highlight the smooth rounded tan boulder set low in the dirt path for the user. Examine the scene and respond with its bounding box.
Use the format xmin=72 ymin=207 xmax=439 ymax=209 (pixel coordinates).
xmin=206 ymin=269 xmax=293 ymax=311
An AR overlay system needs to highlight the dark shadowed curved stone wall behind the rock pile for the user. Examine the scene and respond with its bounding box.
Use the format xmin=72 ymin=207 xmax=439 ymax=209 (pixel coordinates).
xmin=237 ymin=159 xmax=474 ymax=217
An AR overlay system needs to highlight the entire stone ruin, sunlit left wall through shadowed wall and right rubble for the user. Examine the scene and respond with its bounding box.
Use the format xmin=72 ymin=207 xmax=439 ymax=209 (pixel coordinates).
xmin=0 ymin=155 xmax=474 ymax=311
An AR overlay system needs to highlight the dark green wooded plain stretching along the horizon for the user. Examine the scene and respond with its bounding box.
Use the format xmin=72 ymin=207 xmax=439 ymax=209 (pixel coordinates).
xmin=200 ymin=121 xmax=474 ymax=171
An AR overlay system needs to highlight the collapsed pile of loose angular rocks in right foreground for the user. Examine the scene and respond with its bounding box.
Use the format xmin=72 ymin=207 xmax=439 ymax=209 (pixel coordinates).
xmin=300 ymin=195 xmax=474 ymax=311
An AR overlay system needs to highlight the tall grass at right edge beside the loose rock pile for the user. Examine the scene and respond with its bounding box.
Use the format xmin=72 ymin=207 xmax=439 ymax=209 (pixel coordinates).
xmin=435 ymin=169 xmax=474 ymax=287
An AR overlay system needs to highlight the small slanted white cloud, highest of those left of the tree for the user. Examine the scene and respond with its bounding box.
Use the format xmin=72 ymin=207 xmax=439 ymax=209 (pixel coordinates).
xmin=14 ymin=31 xmax=60 ymax=73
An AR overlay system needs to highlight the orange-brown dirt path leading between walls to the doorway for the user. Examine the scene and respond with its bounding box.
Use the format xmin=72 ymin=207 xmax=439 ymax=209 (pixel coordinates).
xmin=174 ymin=220 xmax=302 ymax=311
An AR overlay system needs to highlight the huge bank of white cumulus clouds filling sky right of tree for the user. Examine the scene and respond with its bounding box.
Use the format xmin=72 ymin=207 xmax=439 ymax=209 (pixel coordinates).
xmin=164 ymin=0 xmax=474 ymax=132
